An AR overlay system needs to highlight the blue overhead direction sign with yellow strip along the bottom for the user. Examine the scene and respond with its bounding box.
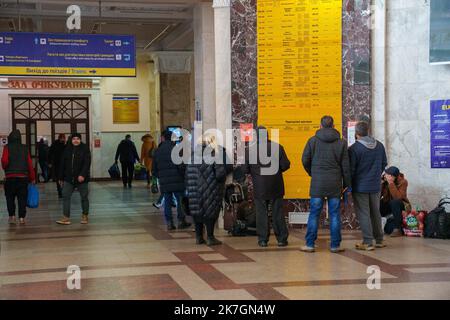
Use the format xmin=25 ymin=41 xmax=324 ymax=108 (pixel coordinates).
xmin=0 ymin=32 xmax=136 ymax=77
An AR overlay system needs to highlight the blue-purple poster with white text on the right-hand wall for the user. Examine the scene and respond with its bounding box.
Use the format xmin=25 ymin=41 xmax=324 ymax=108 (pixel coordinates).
xmin=430 ymin=100 xmax=450 ymax=169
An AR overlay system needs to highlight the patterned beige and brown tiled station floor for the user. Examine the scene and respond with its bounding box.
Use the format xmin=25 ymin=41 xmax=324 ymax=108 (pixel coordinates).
xmin=0 ymin=182 xmax=450 ymax=300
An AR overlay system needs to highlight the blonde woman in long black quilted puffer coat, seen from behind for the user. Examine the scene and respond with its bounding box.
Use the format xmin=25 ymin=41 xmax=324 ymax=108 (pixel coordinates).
xmin=186 ymin=135 xmax=233 ymax=246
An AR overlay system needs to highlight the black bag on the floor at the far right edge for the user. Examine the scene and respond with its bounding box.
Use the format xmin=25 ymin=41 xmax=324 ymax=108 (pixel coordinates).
xmin=424 ymin=198 xmax=450 ymax=239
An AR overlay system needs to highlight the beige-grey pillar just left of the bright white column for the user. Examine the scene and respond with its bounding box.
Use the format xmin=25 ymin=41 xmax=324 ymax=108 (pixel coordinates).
xmin=193 ymin=3 xmax=216 ymax=130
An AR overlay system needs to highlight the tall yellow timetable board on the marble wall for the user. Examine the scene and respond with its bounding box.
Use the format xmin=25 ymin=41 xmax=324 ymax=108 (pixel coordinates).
xmin=257 ymin=0 xmax=342 ymax=199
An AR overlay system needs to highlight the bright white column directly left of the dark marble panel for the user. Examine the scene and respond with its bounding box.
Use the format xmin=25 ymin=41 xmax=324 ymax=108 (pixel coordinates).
xmin=213 ymin=0 xmax=231 ymax=141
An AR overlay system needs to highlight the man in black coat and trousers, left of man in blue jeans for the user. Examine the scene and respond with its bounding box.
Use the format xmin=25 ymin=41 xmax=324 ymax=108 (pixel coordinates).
xmin=244 ymin=127 xmax=291 ymax=247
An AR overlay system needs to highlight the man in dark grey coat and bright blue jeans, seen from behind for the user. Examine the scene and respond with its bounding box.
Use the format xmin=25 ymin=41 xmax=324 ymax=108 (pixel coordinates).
xmin=301 ymin=116 xmax=351 ymax=253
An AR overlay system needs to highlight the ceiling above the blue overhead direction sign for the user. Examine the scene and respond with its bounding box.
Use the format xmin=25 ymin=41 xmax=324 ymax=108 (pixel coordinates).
xmin=0 ymin=0 xmax=212 ymax=51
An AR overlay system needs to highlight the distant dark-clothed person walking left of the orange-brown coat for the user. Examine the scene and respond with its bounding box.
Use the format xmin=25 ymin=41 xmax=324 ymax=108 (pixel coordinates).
xmin=115 ymin=134 xmax=139 ymax=188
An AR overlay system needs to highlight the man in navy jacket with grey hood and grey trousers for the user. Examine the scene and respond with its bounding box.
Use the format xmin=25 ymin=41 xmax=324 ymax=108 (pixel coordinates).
xmin=349 ymin=121 xmax=387 ymax=251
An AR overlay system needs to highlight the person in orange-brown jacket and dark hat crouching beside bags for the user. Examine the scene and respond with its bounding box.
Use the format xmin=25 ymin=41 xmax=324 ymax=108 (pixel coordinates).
xmin=380 ymin=167 xmax=411 ymax=237
